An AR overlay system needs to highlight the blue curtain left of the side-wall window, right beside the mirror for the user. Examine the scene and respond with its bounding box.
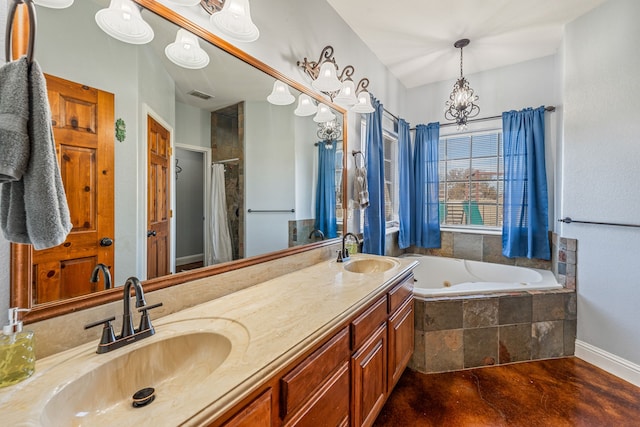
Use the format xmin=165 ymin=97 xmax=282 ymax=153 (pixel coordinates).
xmin=362 ymin=97 xmax=385 ymax=255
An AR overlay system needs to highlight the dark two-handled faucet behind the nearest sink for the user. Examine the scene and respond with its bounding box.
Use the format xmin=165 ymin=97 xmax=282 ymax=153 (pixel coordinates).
xmin=84 ymin=278 xmax=162 ymax=354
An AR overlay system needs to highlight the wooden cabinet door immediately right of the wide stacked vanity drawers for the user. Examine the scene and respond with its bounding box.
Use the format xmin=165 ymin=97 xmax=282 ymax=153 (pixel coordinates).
xmin=351 ymin=323 xmax=388 ymax=427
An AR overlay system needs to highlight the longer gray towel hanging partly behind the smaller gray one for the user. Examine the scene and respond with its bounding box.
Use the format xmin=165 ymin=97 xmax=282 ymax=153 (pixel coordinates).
xmin=0 ymin=59 xmax=72 ymax=249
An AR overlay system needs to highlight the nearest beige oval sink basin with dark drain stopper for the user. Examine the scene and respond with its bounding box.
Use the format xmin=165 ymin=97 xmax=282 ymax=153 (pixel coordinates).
xmin=30 ymin=319 xmax=248 ymax=426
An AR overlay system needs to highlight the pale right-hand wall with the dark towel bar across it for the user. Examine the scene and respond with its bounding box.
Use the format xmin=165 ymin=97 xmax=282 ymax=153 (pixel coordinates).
xmin=561 ymin=0 xmax=640 ymax=370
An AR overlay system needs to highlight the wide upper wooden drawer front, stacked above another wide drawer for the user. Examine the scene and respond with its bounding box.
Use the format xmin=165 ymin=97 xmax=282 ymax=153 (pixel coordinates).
xmin=280 ymin=328 xmax=350 ymax=418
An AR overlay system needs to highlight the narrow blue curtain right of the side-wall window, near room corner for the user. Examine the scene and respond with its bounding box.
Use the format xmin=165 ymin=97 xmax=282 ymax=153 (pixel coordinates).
xmin=398 ymin=119 xmax=414 ymax=249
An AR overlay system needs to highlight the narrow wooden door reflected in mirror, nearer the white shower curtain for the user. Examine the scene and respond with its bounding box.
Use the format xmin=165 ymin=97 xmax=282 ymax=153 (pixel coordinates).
xmin=147 ymin=116 xmax=171 ymax=279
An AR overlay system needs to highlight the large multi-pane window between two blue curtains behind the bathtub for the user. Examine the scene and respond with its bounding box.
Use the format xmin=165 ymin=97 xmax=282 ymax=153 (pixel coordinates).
xmin=438 ymin=130 xmax=504 ymax=227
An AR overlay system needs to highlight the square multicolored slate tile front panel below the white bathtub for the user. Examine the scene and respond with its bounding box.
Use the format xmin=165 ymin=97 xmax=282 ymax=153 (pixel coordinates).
xmin=409 ymin=289 xmax=576 ymax=373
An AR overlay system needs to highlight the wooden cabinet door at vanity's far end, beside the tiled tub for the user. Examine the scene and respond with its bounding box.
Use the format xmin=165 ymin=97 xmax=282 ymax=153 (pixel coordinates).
xmin=388 ymin=298 xmax=414 ymax=393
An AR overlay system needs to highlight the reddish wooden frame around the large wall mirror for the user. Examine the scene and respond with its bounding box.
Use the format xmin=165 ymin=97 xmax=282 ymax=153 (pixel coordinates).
xmin=10 ymin=0 xmax=348 ymax=323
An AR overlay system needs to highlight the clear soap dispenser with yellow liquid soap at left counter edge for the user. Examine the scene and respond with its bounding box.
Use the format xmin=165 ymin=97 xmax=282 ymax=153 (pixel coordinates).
xmin=0 ymin=307 xmax=36 ymax=388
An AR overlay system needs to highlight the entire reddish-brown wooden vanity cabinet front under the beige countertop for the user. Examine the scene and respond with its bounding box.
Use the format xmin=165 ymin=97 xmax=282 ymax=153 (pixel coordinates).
xmin=211 ymin=274 xmax=414 ymax=427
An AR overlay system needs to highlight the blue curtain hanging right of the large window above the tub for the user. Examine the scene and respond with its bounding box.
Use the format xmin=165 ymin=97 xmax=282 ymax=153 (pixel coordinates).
xmin=502 ymin=107 xmax=550 ymax=259
